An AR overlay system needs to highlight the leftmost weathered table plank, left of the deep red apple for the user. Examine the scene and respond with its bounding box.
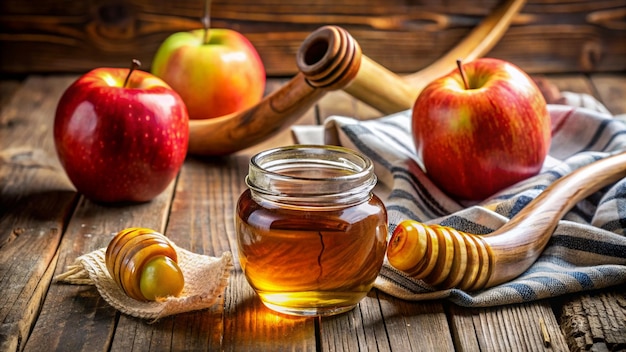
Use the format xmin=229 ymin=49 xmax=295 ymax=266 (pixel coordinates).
xmin=0 ymin=76 xmax=76 ymax=351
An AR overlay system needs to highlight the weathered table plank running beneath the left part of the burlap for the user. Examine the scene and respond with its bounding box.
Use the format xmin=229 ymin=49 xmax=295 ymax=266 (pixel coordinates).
xmin=25 ymin=182 xmax=174 ymax=351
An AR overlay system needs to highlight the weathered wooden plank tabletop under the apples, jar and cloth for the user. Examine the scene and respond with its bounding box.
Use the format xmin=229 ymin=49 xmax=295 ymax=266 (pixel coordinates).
xmin=0 ymin=73 xmax=626 ymax=351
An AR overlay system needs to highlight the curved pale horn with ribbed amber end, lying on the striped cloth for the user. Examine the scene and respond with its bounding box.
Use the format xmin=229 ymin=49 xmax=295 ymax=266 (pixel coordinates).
xmin=387 ymin=152 xmax=626 ymax=291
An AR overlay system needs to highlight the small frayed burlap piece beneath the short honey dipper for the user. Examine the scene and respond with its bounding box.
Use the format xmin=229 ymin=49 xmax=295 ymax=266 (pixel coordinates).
xmin=54 ymin=245 xmax=233 ymax=321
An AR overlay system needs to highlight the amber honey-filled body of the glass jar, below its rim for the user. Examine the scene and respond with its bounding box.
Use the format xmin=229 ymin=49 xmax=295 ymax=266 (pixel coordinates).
xmin=235 ymin=146 xmax=388 ymax=316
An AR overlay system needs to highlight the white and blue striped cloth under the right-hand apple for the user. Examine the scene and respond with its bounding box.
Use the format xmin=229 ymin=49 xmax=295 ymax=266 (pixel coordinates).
xmin=292 ymin=92 xmax=626 ymax=307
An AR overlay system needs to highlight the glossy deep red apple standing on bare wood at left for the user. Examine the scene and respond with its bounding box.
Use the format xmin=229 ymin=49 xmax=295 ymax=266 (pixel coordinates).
xmin=54 ymin=62 xmax=189 ymax=203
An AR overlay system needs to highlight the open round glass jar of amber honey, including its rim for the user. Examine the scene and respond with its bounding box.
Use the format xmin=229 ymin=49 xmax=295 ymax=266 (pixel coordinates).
xmin=235 ymin=145 xmax=387 ymax=316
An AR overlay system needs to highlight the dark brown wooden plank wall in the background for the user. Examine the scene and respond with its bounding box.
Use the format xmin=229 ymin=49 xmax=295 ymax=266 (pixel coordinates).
xmin=0 ymin=0 xmax=626 ymax=76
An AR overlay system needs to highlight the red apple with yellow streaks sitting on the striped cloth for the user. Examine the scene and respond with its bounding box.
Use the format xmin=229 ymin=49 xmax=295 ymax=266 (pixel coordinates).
xmin=412 ymin=58 xmax=551 ymax=200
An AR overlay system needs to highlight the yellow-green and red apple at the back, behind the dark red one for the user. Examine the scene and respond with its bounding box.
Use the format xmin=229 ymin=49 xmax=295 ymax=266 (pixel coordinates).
xmin=151 ymin=28 xmax=266 ymax=119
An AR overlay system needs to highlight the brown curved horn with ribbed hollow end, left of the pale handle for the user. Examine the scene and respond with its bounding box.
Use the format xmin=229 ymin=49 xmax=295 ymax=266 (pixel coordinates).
xmin=189 ymin=26 xmax=362 ymax=155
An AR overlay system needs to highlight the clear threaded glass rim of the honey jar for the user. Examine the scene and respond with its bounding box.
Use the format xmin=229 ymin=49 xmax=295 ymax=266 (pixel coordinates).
xmin=246 ymin=144 xmax=377 ymax=204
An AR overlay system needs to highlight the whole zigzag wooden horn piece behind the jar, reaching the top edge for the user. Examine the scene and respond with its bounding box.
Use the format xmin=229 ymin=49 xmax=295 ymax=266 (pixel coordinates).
xmin=189 ymin=0 xmax=525 ymax=155
